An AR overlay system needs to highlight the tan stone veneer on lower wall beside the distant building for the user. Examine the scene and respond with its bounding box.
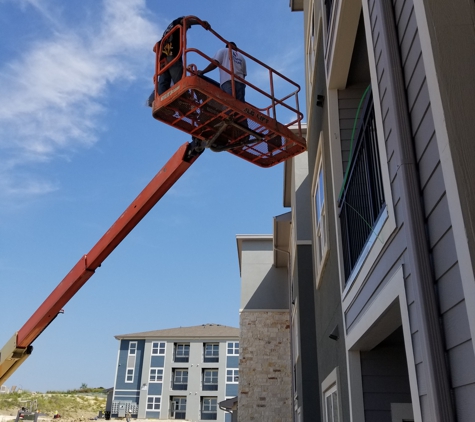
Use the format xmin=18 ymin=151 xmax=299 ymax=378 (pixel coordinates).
xmin=238 ymin=311 xmax=292 ymax=422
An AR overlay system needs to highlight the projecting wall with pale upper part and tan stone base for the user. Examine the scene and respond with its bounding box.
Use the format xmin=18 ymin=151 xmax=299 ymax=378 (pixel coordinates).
xmin=238 ymin=235 xmax=292 ymax=422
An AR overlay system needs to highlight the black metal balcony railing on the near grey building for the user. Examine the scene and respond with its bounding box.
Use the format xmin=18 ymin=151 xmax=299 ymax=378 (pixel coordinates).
xmin=338 ymin=92 xmax=385 ymax=280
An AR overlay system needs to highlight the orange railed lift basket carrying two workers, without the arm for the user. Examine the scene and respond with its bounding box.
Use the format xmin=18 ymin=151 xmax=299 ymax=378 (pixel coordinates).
xmin=152 ymin=16 xmax=306 ymax=167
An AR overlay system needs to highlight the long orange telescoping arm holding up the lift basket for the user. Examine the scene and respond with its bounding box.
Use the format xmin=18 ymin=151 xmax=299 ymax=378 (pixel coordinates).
xmin=0 ymin=143 xmax=201 ymax=385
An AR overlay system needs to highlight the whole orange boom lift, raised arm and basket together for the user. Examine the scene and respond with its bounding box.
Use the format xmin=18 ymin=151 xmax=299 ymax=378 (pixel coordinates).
xmin=0 ymin=16 xmax=306 ymax=385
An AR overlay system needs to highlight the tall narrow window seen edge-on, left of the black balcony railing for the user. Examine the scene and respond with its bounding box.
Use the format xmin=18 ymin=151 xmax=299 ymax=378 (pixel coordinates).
xmin=313 ymin=132 xmax=328 ymax=287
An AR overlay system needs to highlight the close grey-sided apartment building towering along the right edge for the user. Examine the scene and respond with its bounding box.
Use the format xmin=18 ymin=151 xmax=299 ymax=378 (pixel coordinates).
xmin=238 ymin=0 xmax=475 ymax=422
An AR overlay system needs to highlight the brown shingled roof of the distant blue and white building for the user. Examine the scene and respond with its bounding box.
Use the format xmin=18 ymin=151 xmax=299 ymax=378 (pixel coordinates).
xmin=115 ymin=324 xmax=239 ymax=340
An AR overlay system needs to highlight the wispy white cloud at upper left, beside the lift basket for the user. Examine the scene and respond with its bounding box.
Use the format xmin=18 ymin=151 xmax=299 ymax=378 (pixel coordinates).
xmin=0 ymin=0 xmax=158 ymax=201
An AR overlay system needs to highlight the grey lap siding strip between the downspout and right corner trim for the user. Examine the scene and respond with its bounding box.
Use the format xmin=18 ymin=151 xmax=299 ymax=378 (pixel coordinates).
xmin=393 ymin=0 xmax=475 ymax=421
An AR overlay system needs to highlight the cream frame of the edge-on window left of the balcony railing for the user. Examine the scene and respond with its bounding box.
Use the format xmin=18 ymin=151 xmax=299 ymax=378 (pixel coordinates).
xmin=312 ymin=132 xmax=330 ymax=289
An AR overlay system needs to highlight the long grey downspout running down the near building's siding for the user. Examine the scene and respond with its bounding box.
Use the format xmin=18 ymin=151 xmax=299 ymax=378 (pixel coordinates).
xmin=376 ymin=0 xmax=455 ymax=422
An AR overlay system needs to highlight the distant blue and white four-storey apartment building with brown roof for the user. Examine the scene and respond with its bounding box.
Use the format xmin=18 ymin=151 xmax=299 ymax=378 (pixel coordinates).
xmin=111 ymin=324 xmax=239 ymax=422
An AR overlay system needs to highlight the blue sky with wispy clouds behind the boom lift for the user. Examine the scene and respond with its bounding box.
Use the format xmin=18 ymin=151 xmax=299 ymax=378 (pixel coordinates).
xmin=0 ymin=0 xmax=304 ymax=392
